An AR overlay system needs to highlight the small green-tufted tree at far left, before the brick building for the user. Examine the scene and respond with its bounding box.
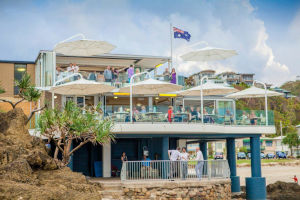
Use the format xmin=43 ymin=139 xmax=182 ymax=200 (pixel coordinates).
xmin=0 ymin=73 xmax=45 ymax=124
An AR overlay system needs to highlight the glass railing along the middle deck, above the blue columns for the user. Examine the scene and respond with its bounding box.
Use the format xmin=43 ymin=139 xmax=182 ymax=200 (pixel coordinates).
xmin=105 ymin=106 xmax=274 ymax=126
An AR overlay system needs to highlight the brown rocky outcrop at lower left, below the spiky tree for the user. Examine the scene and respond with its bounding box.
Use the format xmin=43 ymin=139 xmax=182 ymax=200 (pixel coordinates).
xmin=0 ymin=108 xmax=101 ymax=200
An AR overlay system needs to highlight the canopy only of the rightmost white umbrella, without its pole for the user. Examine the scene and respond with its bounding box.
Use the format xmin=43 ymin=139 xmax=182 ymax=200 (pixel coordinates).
xmin=226 ymin=86 xmax=284 ymax=99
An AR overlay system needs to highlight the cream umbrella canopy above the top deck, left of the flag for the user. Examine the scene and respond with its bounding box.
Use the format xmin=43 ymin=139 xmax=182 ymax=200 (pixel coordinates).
xmin=54 ymin=39 xmax=116 ymax=56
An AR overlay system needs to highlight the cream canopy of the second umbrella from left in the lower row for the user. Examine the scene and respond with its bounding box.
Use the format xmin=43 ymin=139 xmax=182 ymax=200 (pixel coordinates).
xmin=119 ymin=78 xmax=182 ymax=95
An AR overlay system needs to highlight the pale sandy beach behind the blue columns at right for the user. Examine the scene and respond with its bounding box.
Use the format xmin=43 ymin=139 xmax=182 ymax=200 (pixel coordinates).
xmin=237 ymin=165 xmax=300 ymax=186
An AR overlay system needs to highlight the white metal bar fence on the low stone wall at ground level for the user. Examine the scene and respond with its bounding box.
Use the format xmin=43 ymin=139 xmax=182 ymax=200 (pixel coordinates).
xmin=121 ymin=160 xmax=230 ymax=181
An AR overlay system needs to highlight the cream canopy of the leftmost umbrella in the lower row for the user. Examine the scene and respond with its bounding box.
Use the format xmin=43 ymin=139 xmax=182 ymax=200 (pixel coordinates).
xmin=50 ymin=79 xmax=114 ymax=95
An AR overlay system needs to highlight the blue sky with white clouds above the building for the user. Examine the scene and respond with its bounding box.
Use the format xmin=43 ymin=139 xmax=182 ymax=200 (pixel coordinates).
xmin=0 ymin=0 xmax=300 ymax=85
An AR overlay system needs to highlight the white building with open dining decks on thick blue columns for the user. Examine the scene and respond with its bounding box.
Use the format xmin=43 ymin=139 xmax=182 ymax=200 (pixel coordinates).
xmin=0 ymin=48 xmax=275 ymax=200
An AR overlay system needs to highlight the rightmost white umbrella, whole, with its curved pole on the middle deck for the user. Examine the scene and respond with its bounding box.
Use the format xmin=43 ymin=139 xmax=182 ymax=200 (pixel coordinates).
xmin=226 ymin=80 xmax=284 ymax=125
